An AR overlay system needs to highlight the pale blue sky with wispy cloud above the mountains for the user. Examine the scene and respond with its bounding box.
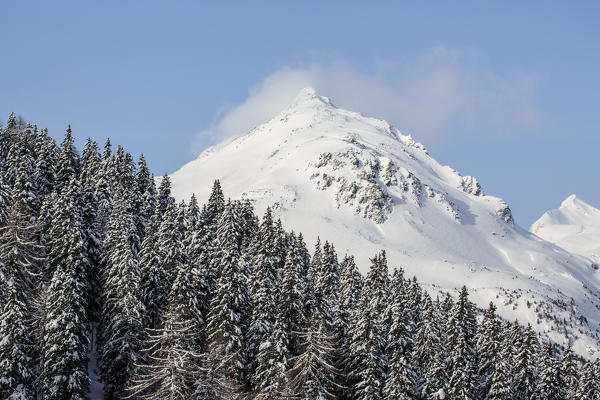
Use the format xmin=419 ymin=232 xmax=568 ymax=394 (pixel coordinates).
xmin=0 ymin=1 xmax=600 ymax=227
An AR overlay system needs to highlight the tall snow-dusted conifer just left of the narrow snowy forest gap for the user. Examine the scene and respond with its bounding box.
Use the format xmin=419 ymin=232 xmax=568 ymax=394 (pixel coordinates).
xmin=41 ymin=225 xmax=90 ymax=400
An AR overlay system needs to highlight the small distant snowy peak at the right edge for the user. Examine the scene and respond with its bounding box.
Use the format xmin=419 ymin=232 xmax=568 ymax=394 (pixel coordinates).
xmin=530 ymin=194 xmax=600 ymax=264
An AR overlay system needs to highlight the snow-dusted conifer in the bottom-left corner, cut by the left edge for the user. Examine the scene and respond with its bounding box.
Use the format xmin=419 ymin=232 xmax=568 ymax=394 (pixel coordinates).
xmin=0 ymin=276 xmax=35 ymax=400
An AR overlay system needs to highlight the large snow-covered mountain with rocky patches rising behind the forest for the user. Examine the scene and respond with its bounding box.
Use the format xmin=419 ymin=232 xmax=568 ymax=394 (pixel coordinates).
xmin=172 ymin=88 xmax=600 ymax=357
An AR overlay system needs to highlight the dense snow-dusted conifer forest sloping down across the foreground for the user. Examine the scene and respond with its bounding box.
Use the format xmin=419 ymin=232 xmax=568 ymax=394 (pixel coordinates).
xmin=0 ymin=114 xmax=600 ymax=400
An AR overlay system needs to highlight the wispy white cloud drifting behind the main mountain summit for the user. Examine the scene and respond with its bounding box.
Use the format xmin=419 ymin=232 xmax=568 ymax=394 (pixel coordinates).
xmin=194 ymin=47 xmax=539 ymax=154
